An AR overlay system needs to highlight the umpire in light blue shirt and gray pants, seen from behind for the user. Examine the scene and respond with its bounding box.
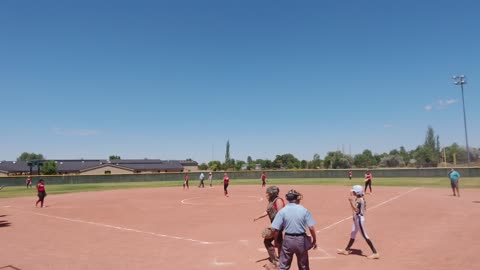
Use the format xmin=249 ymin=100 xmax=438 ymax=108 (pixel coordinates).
xmin=272 ymin=189 xmax=317 ymax=270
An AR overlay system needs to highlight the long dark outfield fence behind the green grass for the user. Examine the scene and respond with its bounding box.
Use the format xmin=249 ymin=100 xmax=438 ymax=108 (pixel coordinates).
xmin=0 ymin=168 xmax=480 ymax=186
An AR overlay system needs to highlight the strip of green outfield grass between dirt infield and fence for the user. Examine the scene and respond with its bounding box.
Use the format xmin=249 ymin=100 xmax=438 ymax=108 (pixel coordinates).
xmin=0 ymin=177 xmax=480 ymax=198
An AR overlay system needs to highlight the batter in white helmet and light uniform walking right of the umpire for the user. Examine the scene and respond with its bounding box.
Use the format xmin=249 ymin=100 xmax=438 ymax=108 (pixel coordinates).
xmin=337 ymin=185 xmax=380 ymax=259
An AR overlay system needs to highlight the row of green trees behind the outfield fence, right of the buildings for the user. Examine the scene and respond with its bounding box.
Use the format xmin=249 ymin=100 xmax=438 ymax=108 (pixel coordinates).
xmin=199 ymin=127 xmax=480 ymax=171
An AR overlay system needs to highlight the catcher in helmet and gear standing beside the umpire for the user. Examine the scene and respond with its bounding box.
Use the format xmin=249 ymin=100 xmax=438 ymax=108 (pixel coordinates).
xmin=253 ymin=186 xmax=285 ymax=265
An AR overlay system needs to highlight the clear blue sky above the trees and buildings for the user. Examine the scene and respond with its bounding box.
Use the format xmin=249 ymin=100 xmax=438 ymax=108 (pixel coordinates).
xmin=0 ymin=0 xmax=480 ymax=162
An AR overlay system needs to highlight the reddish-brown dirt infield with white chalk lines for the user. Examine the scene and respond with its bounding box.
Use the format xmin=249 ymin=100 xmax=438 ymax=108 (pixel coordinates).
xmin=0 ymin=185 xmax=480 ymax=270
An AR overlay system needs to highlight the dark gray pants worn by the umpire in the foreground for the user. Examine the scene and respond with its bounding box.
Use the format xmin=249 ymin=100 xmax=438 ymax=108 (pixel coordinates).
xmin=278 ymin=235 xmax=312 ymax=270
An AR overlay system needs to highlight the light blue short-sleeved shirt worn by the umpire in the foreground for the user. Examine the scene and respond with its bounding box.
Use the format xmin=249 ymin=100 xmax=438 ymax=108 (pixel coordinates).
xmin=272 ymin=203 xmax=315 ymax=234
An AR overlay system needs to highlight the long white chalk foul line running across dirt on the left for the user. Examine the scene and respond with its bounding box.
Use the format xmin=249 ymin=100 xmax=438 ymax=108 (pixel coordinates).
xmin=7 ymin=207 xmax=213 ymax=245
